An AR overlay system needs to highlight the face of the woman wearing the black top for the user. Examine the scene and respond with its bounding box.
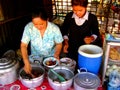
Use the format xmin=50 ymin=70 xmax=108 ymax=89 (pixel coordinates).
xmin=72 ymin=5 xmax=86 ymax=18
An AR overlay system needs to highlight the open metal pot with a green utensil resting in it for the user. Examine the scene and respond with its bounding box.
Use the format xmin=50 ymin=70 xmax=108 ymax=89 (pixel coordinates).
xmin=48 ymin=66 xmax=74 ymax=90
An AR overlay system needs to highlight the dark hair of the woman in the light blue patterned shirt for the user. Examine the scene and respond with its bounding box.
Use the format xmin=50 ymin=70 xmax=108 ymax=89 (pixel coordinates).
xmin=32 ymin=8 xmax=48 ymax=20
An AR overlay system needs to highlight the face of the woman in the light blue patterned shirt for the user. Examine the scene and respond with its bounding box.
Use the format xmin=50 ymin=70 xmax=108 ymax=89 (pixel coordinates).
xmin=32 ymin=17 xmax=47 ymax=30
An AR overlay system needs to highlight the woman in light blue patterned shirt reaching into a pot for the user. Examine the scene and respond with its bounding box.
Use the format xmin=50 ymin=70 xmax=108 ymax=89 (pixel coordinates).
xmin=21 ymin=9 xmax=63 ymax=73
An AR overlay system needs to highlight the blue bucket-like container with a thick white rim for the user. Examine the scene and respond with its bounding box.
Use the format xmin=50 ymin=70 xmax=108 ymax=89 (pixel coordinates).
xmin=78 ymin=44 xmax=103 ymax=75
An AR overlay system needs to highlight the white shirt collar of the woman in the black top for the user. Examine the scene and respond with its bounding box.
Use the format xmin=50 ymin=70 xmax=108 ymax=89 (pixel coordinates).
xmin=72 ymin=11 xmax=89 ymax=26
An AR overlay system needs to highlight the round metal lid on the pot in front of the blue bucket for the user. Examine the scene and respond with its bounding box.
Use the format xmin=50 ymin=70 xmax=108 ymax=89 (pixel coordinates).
xmin=74 ymin=72 xmax=100 ymax=89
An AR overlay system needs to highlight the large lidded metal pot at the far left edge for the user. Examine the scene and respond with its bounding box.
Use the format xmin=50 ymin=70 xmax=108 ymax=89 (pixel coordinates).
xmin=0 ymin=57 xmax=19 ymax=85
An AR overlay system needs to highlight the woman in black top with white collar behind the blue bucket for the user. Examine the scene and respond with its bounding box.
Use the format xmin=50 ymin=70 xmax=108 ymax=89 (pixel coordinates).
xmin=61 ymin=0 xmax=101 ymax=61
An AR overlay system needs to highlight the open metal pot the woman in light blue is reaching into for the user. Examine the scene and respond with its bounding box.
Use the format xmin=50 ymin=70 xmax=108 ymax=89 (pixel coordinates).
xmin=19 ymin=63 xmax=45 ymax=88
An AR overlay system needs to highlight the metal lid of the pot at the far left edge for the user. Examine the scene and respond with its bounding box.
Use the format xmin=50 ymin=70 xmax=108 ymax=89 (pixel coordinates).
xmin=0 ymin=58 xmax=16 ymax=69
